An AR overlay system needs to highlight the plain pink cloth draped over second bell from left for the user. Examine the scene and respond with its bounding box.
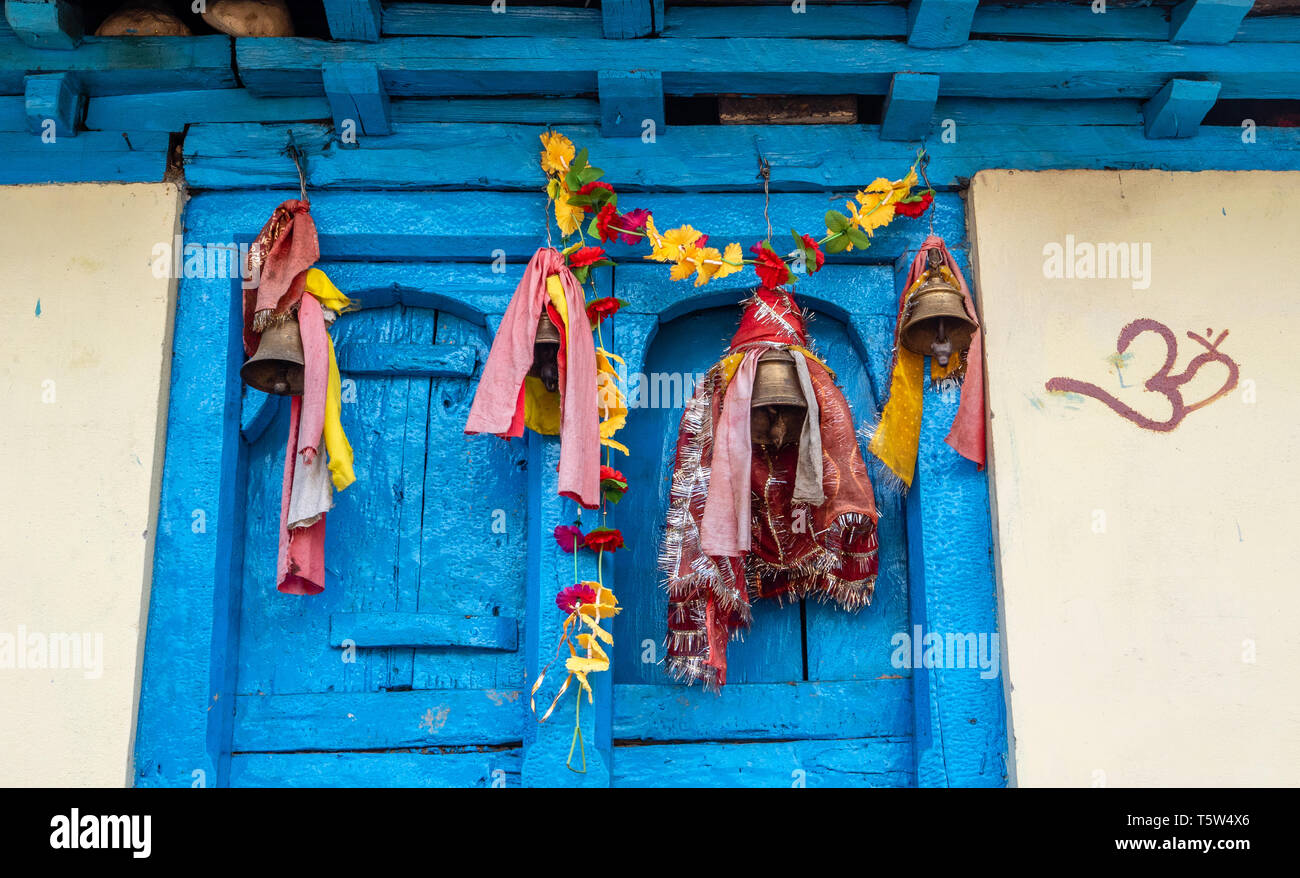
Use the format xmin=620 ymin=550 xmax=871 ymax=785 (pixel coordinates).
xmin=465 ymin=247 xmax=601 ymax=509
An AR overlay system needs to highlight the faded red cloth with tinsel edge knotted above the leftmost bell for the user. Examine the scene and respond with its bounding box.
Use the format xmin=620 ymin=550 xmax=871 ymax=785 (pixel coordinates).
xmin=243 ymin=198 xmax=321 ymax=356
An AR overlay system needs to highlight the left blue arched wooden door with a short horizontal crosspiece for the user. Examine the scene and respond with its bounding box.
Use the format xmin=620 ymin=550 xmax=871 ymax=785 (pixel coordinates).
xmin=230 ymin=304 xmax=527 ymax=786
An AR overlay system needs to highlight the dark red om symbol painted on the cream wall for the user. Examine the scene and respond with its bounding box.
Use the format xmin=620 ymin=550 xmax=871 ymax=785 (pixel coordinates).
xmin=1047 ymin=317 xmax=1238 ymax=433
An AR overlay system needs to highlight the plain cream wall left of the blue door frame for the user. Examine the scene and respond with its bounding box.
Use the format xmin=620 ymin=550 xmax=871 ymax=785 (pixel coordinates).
xmin=0 ymin=183 xmax=181 ymax=786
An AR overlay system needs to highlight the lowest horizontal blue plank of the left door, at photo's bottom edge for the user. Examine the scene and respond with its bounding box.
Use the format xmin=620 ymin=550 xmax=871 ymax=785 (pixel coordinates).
xmin=230 ymin=748 xmax=521 ymax=790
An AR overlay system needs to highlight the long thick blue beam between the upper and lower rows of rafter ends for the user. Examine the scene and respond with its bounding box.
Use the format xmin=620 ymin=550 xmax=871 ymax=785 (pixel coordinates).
xmin=235 ymin=36 xmax=1300 ymax=99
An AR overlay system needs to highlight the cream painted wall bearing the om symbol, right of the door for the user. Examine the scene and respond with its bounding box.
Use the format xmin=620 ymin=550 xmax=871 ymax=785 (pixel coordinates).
xmin=970 ymin=170 xmax=1300 ymax=787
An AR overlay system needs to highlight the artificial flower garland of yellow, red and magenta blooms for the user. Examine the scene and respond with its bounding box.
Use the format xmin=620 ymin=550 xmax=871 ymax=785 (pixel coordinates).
xmin=530 ymin=131 xmax=935 ymax=771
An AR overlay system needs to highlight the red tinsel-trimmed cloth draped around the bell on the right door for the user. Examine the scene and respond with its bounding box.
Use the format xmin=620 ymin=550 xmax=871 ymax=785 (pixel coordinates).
xmin=659 ymin=289 xmax=879 ymax=688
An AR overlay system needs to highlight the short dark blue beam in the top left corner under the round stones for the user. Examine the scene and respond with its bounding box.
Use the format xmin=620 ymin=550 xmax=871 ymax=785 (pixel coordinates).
xmin=0 ymin=35 xmax=233 ymax=95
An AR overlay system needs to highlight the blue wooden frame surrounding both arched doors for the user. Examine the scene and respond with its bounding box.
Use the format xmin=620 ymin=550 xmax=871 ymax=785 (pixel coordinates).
xmin=135 ymin=182 xmax=1006 ymax=786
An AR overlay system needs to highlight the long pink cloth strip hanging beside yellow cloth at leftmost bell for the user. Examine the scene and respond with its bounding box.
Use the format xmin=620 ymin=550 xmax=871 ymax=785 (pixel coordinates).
xmin=276 ymin=295 xmax=329 ymax=594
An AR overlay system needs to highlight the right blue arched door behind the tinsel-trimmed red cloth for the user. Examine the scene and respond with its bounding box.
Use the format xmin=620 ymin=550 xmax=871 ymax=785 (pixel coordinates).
xmin=612 ymin=265 xmax=915 ymax=787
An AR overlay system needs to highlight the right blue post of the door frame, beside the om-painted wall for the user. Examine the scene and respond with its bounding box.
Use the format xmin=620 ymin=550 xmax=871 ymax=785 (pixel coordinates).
xmin=898 ymin=251 xmax=1006 ymax=787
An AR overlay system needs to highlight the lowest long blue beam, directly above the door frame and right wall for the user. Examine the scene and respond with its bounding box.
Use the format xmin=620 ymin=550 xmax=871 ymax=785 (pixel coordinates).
xmin=185 ymin=120 xmax=1300 ymax=193
